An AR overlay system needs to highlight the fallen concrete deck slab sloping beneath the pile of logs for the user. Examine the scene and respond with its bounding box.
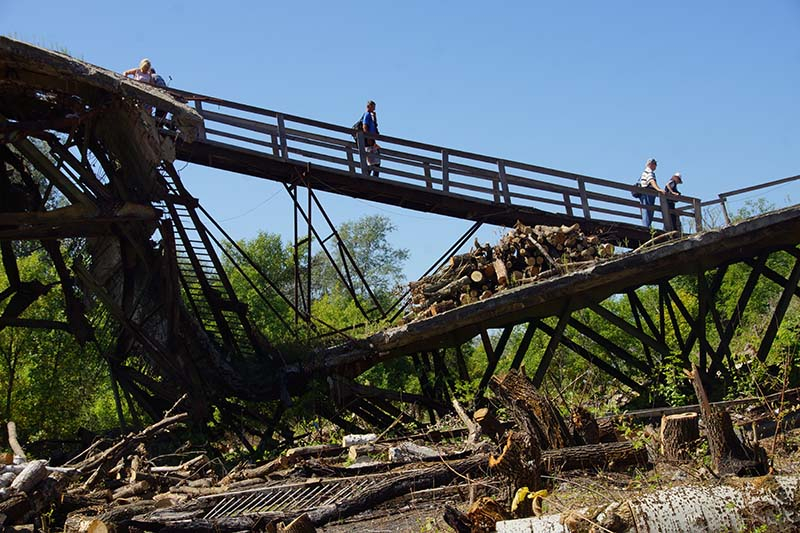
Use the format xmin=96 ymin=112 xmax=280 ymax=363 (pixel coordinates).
xmin=323 ymin=206 xmax=800 ymax=374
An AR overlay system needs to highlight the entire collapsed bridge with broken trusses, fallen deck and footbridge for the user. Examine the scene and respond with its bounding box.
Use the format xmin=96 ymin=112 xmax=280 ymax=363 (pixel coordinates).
xmin=0 ymin=38 xmax=800 ymax=443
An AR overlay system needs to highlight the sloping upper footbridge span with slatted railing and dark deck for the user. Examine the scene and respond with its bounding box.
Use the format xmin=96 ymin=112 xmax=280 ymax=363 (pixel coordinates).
xmin=171 ymin=91 xmax=702 ymax=243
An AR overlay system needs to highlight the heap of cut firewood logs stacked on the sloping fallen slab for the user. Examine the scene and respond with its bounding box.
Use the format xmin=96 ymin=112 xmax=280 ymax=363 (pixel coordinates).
xmin=406 ymin=222 xmax=614 ymax=320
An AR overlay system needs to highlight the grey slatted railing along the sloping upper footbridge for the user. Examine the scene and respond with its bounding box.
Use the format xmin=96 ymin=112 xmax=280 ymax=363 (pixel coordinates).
xmin=170 ymin=89 xmax=702 ymax=230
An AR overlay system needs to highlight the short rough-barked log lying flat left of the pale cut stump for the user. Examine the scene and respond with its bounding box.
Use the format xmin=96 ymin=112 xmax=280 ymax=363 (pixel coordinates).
xmin=542 ymin=441 xmax=649 ymax=472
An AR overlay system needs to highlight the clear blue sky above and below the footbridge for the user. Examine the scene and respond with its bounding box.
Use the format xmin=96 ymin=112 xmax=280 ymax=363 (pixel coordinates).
xmin=0 ymin=0 xmax=800 ymax=278
